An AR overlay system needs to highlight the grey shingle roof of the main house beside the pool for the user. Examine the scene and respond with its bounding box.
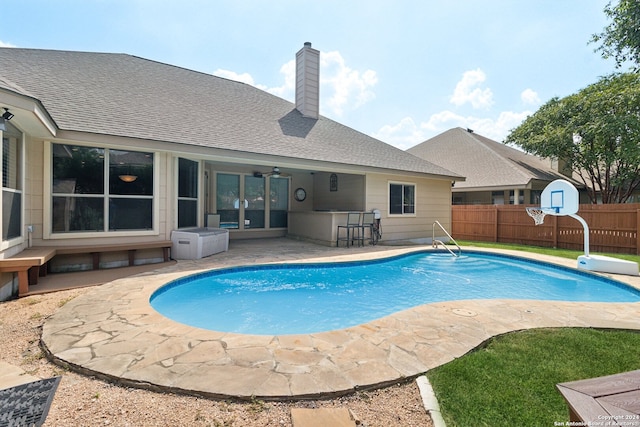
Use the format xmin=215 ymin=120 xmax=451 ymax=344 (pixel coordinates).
xmin=0 ymin=48 xmax=461 ymax=178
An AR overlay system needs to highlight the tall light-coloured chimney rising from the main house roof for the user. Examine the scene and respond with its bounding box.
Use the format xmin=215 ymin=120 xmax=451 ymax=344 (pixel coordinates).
xmin=296 ymin=42 xmax=320 ymax=119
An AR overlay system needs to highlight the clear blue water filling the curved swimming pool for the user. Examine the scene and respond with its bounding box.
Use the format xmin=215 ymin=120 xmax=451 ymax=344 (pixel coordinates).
xmin=151 ymin=252 xmax=640 ymax=335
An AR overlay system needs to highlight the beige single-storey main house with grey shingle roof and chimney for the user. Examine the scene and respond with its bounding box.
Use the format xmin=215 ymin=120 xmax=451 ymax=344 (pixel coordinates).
xmin=0 ymin=43 xmax=463 ymax=297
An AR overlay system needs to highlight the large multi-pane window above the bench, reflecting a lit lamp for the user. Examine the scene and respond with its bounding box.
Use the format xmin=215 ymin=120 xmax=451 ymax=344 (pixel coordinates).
xmin=51 ymin=144 xmax=154 ymax=233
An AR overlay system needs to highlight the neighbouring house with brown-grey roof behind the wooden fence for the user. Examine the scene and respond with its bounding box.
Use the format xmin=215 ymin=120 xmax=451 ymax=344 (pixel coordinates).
xmin=407 ymin=127 xmax=584 ymax=205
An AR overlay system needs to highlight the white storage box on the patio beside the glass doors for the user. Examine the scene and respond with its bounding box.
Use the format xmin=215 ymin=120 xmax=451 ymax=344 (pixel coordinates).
xmin=171 ymin=228 xmax=229 ymax=259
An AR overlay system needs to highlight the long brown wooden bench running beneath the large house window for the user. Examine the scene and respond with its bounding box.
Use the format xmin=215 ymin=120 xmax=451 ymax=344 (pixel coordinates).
xmin=0 ymin=240 xmax=171 ymax=296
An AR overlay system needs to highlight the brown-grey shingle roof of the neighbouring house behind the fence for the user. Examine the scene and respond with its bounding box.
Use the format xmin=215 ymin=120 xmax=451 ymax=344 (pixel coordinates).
xmin=407 ymin=127 xmax=578 ymax=190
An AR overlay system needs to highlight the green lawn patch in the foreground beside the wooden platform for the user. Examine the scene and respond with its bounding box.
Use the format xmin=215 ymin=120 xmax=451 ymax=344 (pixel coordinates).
xmin=427 ymin=328 xmax=640 ymax=427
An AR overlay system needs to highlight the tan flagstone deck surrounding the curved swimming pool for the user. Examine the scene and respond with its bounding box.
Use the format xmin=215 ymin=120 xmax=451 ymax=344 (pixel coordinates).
xmin=42 ymin=239 xmax=640 ymax=399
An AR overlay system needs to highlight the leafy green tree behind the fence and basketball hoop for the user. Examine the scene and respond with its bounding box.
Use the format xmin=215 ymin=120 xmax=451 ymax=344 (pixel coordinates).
xmin=505 ymin=73 xmax=640 ymax=203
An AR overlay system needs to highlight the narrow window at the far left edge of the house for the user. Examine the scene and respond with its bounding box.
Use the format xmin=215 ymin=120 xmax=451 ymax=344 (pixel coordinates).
xmin=2 ymin=123 xmax=22 ymax=240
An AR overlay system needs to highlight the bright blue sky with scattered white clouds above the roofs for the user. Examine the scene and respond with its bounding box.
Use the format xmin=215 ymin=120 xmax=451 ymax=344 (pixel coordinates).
xmin=0 ymin=0 xmax=616 ymax=149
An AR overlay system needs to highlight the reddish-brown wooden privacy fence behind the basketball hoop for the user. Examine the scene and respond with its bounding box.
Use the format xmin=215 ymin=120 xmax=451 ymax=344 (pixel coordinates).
xmin=451 ymin=203 xmax=640 ymax=255
